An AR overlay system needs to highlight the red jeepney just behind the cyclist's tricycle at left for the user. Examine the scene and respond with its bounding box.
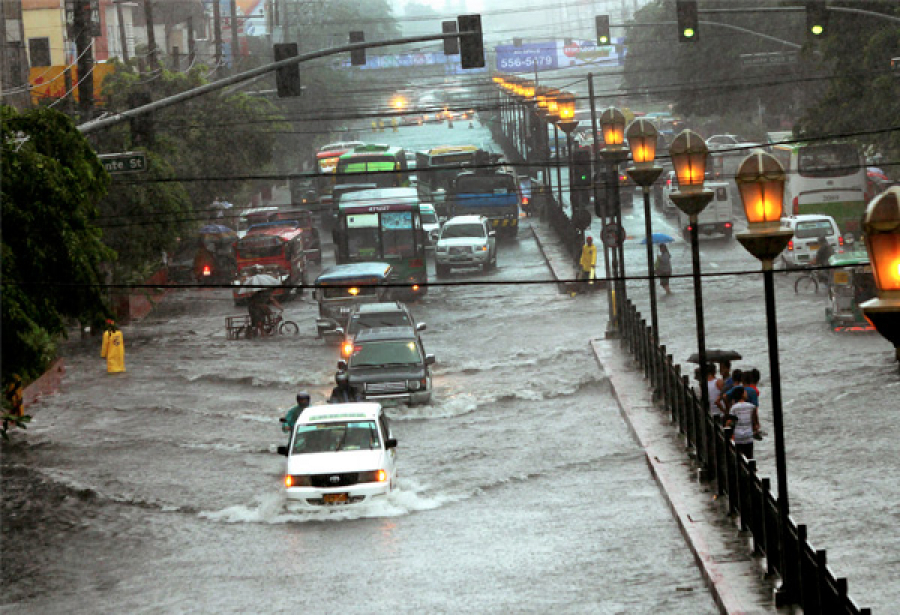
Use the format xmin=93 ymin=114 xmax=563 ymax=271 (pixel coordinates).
xmin=233 ymin=220 xmax=306 ymax=305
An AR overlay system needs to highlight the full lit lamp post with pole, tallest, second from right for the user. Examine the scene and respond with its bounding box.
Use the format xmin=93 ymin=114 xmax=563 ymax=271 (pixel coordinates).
xmin=735 ymin=150 xmax=797 ymax=604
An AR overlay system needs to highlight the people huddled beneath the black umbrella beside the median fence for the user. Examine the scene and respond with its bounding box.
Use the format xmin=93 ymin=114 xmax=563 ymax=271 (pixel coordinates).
xmin=704 ymin=361 xmax=762 ymax=459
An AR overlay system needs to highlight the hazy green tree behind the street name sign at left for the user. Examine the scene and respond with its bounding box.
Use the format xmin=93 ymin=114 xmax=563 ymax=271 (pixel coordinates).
xmin=96 ymin=65 xmax=284 ymax=280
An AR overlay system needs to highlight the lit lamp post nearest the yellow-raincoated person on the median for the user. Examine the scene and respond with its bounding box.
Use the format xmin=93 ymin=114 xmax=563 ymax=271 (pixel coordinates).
xmin=597 ymin=107 xmax=628 ymax=337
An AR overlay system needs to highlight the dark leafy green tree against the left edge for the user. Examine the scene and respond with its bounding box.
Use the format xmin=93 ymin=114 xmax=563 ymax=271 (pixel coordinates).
xmin=0 ymin=106 xmax=115 ymax=384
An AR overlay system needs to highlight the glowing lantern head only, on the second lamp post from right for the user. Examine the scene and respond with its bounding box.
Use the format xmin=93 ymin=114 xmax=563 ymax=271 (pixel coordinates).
xmin=734 ymin=150 xmax=785 ymax=228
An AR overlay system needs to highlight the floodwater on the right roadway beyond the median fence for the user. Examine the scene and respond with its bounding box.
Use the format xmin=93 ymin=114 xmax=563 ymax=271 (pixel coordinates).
xmin=612 ymin=177 xmax=900 ymax=613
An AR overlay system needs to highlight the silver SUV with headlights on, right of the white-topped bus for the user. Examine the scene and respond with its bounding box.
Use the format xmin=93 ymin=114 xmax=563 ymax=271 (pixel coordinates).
xmin=434 ymin=216 xmax=497 ymax=276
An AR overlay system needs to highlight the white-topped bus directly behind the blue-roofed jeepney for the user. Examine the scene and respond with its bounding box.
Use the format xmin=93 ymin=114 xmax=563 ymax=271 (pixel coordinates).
xmin=334 ymin=188 xmax=428 ymax=300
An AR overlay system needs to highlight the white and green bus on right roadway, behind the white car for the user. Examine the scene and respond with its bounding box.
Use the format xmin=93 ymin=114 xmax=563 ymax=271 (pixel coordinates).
xmin=772 ymin=143 xmax=866 ymax=239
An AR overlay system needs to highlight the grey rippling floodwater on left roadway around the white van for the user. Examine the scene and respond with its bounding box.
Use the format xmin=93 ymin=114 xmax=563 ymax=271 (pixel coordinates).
xmin=3 ymin=122 xmax=717 ymax=615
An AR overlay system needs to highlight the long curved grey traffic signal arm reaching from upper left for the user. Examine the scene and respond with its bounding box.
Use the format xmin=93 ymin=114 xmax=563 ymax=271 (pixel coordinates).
xmin=78 ymin=31 xmax=481 ymax=134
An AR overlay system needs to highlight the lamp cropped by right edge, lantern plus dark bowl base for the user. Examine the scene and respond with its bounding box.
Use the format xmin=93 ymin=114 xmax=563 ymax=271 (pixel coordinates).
xmin=860 ymin=186 xmax=900 ymax=361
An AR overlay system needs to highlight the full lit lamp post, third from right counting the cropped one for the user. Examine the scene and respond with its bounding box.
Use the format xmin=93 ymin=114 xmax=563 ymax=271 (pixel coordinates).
xmin=669 ymin=130 xmax=713 ymax=462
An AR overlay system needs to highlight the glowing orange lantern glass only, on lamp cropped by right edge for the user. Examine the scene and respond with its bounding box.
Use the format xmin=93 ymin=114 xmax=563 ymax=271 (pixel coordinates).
xmin=863 ymin=186 xmax=900 ymax=299
